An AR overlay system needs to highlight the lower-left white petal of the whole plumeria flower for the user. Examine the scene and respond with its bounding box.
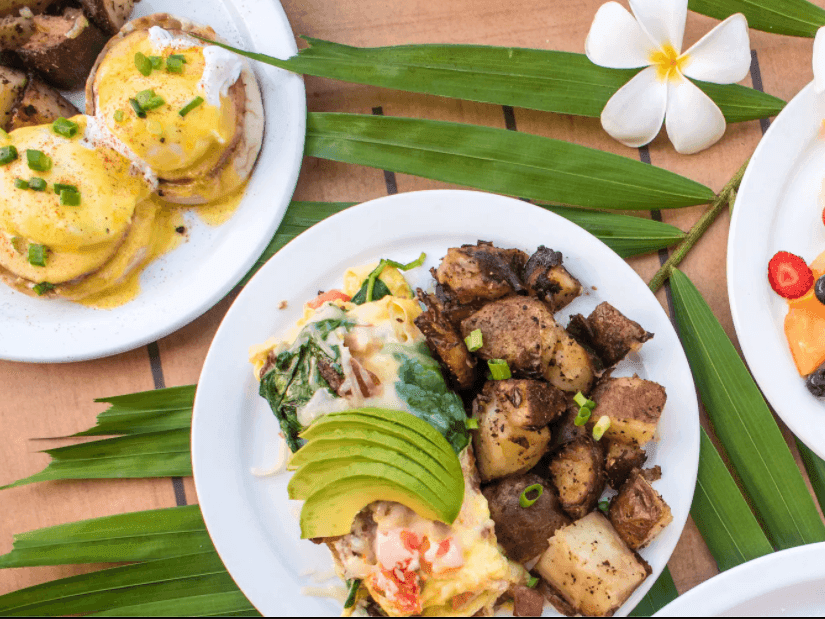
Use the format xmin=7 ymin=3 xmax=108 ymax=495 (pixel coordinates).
xmin=602 ymin=67 xmax=667 ymax=148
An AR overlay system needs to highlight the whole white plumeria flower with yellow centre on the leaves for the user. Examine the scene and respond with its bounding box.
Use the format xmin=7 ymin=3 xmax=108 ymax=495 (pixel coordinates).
xmin=585 ymin=0 xmax=748 ymax=155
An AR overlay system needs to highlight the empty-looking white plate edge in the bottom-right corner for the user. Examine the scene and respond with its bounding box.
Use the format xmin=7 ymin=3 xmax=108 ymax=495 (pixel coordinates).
xmin=653 ymin=542 xmax=825 ymax=617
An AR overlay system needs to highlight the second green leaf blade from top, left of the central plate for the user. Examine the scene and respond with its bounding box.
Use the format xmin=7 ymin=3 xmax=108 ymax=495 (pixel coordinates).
xmin=0 ymin=428 xmax=192 ymax=490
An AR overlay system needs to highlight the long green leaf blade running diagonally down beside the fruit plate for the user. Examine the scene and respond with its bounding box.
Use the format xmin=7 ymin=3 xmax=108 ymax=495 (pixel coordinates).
xmin=670 ymin=269 xmax=825 ymax=549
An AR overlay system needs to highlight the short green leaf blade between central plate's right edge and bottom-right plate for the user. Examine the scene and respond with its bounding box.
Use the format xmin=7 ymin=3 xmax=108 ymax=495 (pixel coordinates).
xmin=690 ymin=429 xmax=773 ymax=571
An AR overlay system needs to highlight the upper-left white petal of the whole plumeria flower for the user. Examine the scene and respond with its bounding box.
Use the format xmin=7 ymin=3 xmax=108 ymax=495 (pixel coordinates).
xmin=584 ymin=2 xmax=657 ymax=69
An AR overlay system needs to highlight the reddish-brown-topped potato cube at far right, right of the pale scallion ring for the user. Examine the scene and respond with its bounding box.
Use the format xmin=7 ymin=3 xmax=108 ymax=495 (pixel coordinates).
xmin=588 ymin=376 xmax=667 ymax=446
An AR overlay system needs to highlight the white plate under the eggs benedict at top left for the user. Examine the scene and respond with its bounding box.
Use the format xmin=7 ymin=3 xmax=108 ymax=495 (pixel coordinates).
xmin=0 ymin=0 xmax=306 ymax=363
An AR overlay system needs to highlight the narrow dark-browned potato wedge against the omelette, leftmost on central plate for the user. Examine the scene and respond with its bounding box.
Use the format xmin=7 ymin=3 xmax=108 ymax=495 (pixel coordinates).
xmin=415 ymin=288 xmax=476 ymax=389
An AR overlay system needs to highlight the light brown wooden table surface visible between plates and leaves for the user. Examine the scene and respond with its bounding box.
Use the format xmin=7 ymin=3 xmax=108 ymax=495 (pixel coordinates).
xmin=0 ymin=0 xmax=825 ymax=612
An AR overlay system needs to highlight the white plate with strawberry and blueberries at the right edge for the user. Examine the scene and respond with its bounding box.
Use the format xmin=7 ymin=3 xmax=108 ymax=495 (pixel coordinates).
xmin=728 ymin=84 xmax=825 ymax=458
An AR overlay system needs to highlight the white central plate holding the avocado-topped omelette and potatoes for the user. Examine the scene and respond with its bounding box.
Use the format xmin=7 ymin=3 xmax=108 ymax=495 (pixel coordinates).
xmin=192 ymin=191 xmax=699 ymax=616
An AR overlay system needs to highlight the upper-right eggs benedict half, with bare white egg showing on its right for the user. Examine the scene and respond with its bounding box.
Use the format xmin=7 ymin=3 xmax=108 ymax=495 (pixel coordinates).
xmin=86 ymin=13 xmax=263 ymax=204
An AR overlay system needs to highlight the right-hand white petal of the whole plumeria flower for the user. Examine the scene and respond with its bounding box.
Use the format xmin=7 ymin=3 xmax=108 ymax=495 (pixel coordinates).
xmin=682 ymin=13 xmax=751 ymax=84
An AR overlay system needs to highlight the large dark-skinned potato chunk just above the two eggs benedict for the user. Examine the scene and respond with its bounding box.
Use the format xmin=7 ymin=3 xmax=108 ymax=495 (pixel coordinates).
xmin=17 ymin=9 xmax=107 ymax=90
